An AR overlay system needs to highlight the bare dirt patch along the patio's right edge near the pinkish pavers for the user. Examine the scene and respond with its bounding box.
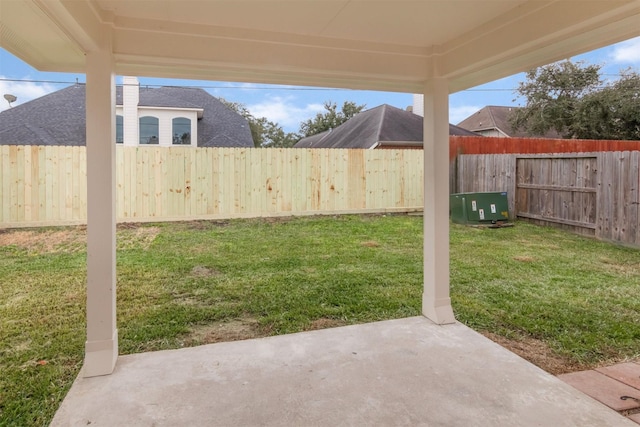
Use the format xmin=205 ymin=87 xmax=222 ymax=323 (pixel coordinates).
xmin=482 ymin=332 xmax=585 ymax=375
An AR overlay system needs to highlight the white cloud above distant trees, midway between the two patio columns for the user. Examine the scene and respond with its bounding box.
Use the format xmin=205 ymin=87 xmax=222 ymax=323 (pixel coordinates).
xmin=247 ymin=96 xmax=324 ymax=130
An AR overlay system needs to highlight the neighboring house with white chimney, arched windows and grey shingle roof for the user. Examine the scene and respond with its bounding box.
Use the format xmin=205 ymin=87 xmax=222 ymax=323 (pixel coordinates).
xmin=0 ymin=77 xmax=253 ymax=147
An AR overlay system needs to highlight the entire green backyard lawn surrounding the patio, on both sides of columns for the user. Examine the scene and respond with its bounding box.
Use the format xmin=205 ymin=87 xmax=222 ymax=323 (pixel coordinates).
xmin=0 ymin=215 xmax=640 ymax=426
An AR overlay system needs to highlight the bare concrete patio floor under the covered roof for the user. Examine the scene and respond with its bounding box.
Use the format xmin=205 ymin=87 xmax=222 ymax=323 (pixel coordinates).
xmin=51 ymin=317 xmax=637 ymax=427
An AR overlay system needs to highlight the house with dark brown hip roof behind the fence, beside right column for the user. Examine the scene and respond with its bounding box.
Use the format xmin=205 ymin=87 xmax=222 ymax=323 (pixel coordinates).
xmin=294 ymin=104 xmax=478 ymax=149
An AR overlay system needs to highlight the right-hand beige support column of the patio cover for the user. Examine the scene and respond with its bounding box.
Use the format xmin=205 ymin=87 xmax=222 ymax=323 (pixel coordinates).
xmin=422 ymin=78 xmax=456 ymax=324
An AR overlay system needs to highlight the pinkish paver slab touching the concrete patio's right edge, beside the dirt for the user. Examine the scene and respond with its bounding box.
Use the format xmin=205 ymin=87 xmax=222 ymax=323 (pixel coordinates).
xmin=558 ymin=370 xmax=640 ymax=411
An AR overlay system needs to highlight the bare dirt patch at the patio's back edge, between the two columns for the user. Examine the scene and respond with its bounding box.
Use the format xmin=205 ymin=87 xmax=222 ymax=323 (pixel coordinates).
xmin=183 ymin=317 xmax=266 ymax=346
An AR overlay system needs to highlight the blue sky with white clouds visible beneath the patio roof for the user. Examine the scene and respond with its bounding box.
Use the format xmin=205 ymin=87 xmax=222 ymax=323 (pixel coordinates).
xmin=0 ymin=37 xmax=640 ymax=132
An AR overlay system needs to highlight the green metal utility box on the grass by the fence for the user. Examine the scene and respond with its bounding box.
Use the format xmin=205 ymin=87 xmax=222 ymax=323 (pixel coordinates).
xmin=449 ymin=192 xmax=509 ymax=226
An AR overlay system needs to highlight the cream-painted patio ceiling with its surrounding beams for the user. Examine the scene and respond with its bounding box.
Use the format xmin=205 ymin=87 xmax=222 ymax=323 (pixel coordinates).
xmin=0 ymin=0 xmax=640 ymax=93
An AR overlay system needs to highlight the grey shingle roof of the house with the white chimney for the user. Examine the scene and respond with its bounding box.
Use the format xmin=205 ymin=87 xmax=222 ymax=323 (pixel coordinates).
xmin=0 ymin=84 xmax=253 ymax=147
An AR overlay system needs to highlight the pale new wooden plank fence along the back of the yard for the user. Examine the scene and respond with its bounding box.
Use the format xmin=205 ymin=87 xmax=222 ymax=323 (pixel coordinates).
xmin=0 ymin=146 xmax=423 ymax=227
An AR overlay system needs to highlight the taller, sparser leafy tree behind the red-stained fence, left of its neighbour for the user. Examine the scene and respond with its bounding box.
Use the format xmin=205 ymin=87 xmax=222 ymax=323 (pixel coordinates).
xmin=511 ymin=61 xmax=601 ymax=138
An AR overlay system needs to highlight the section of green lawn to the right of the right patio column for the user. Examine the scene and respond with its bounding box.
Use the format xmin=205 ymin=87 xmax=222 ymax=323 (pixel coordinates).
xmin=451 ymin=223 xmax=640 ymax=373
